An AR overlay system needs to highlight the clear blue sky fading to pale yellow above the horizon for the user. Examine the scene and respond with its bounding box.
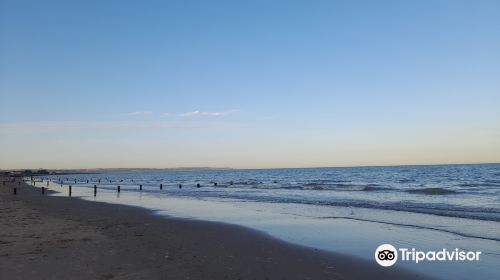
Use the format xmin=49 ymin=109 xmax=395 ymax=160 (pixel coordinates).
xmin=0 ymin=0 xmax=500 ymax=169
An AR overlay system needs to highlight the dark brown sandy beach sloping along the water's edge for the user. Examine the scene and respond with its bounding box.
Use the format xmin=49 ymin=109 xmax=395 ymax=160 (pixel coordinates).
xmin=0 ymin=177 xmax=436 ymax=280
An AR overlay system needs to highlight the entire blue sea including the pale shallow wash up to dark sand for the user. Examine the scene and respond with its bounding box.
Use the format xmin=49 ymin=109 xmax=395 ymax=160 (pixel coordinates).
xmin=38 ymin=164 xmax=500 ymax=279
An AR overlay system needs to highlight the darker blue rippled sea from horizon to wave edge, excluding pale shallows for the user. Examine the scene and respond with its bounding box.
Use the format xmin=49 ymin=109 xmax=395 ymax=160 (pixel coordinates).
xmin=52 ymin=164 xmax=500 ymax=221
